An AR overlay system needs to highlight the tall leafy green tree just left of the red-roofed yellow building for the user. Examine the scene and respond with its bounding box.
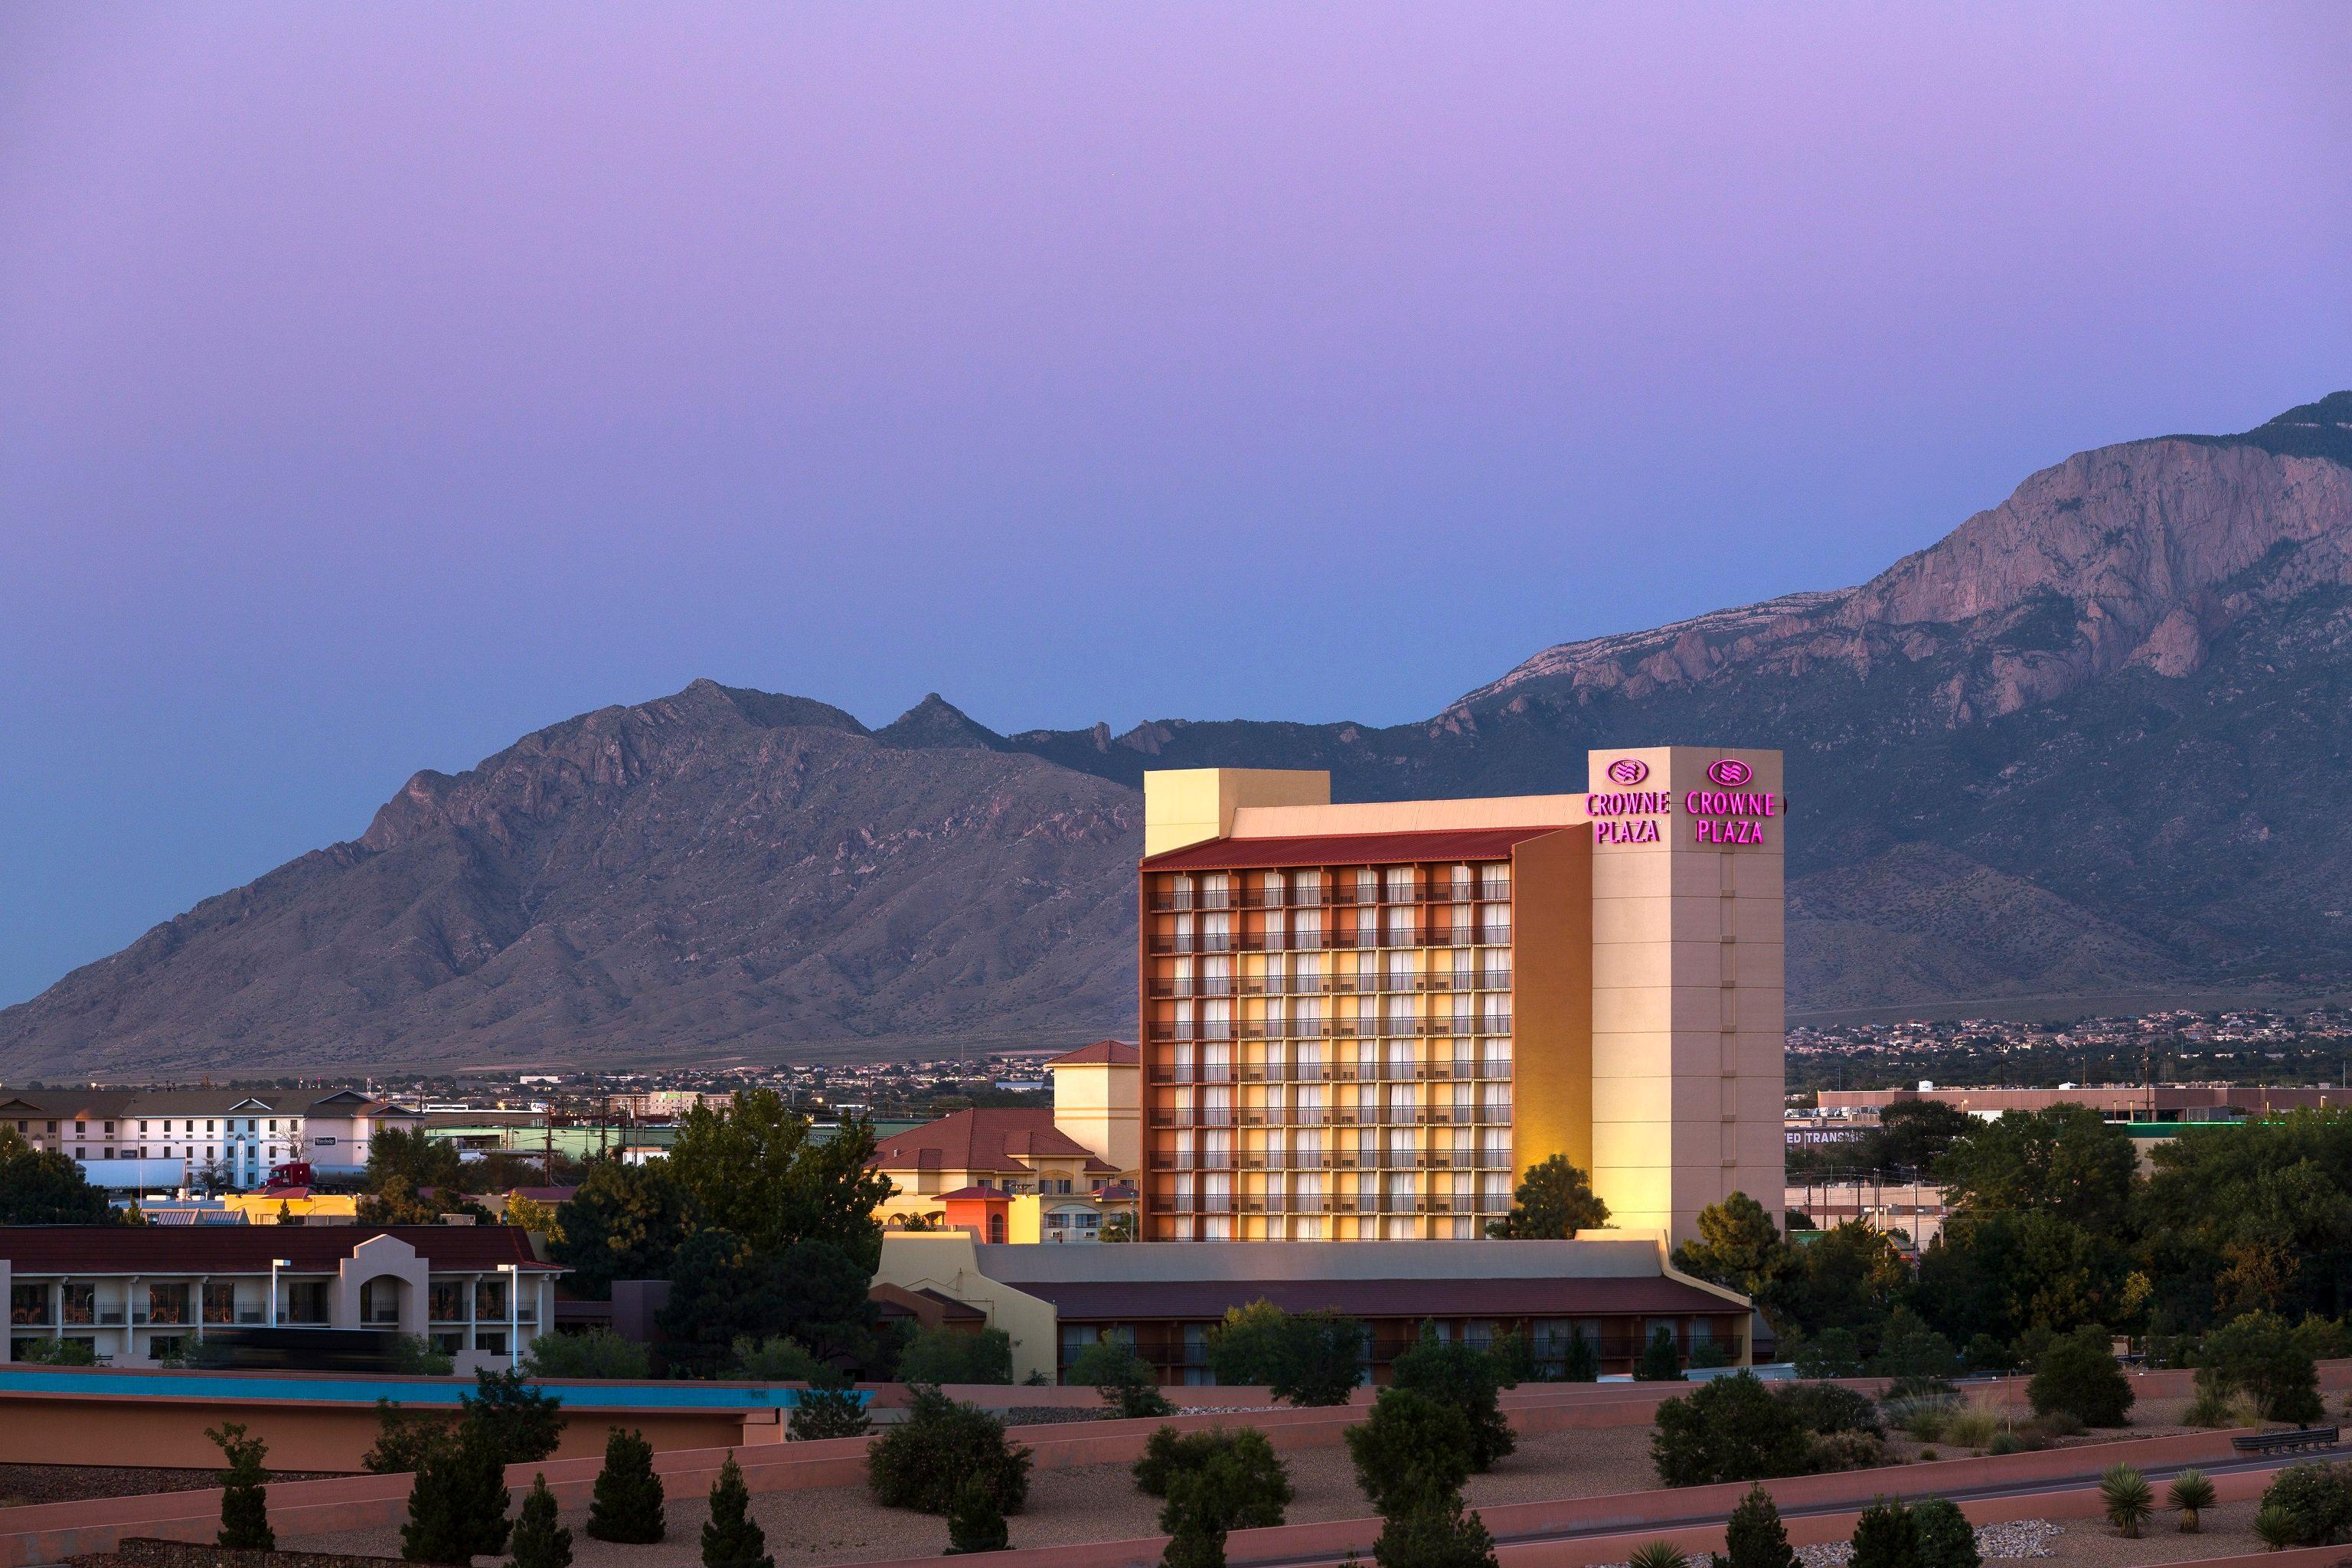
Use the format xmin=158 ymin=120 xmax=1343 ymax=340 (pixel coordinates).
xmin=668 ymin=1089 xmax=891 ymax=1279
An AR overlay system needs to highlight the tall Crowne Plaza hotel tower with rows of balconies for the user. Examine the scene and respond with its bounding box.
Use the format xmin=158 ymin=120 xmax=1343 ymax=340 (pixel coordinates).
xmin=1138 ymin=745 xmax=1788 ymax=1241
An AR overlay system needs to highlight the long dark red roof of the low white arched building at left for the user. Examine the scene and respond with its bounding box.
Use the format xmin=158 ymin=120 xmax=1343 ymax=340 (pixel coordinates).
xmin=0 ymin=1225 xmax=555 ymax=1274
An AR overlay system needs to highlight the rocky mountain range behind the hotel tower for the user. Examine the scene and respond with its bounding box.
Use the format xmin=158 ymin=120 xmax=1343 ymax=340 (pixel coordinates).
xmin=0 ymin=393 xmax=2352 ymax=1076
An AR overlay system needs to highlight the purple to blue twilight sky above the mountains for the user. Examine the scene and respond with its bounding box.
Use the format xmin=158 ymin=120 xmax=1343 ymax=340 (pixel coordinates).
xmin=0 ymin=0 xmax=2352 ymax=1004
